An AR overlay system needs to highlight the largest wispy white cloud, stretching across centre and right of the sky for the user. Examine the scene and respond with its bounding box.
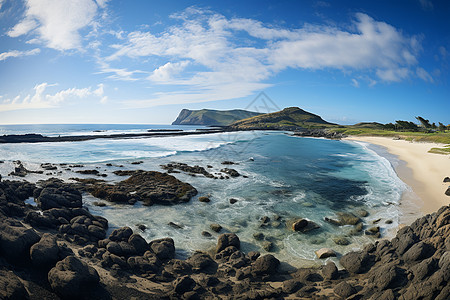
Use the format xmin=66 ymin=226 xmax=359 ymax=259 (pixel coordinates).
xmin=105 ymin=8 xmax=423 ymax=105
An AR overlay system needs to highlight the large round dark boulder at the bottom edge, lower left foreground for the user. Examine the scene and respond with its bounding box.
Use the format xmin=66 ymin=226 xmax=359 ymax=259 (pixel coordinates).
xmin=48 ymin=256 xmax=100 ymax=299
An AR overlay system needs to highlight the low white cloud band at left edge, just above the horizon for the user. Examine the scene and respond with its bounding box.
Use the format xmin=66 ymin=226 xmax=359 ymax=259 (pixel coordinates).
xmin=0 ymin=82 xmax=107 ymax=112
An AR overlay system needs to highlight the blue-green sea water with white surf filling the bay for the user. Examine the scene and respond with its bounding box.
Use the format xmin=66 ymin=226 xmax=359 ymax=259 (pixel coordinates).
xmin=0 ymin=125 xmax=414 ymax=266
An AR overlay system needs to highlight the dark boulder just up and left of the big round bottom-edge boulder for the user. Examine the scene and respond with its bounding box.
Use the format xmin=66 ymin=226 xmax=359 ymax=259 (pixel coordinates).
xmin=30 ymin=233 xmax=59 ymax=269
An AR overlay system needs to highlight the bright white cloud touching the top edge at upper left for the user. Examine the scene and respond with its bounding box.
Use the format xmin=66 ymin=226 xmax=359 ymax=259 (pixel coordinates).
xmin=8 ymin=0 xmax=106 ymax=50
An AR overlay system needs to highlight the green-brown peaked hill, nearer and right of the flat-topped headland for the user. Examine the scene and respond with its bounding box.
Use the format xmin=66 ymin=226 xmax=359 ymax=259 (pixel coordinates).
xmin=231 ymin=107 xmax=336 ymax=130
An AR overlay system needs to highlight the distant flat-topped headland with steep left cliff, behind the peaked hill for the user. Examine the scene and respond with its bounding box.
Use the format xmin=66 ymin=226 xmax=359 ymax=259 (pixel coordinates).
xmin=172 ymin=109 xmax=260 ymax=126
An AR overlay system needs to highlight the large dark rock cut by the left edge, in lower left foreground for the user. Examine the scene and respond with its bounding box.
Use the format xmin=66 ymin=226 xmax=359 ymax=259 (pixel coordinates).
xmin=0 ymin=219 xmax=40 ymax=261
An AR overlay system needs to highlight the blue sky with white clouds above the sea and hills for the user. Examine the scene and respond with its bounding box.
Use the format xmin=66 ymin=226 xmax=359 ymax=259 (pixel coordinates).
xmin=0 ymin=0 xmax=450 ymax=124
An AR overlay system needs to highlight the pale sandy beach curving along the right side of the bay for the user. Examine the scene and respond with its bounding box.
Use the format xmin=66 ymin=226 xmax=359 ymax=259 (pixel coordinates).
xmin=348 ymin=136 xmax=450 ymax=213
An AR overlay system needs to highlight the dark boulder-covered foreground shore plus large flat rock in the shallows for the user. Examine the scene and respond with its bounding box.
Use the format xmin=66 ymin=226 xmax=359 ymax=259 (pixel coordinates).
xmin=0 ymin=170 xmax=450 ymax=300
